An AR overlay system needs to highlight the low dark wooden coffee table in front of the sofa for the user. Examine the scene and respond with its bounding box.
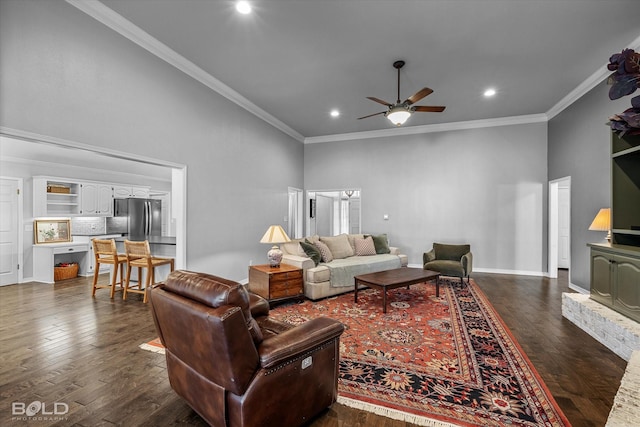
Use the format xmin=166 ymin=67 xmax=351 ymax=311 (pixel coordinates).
xmin=353 ymin=267 xmax=440 ymax=313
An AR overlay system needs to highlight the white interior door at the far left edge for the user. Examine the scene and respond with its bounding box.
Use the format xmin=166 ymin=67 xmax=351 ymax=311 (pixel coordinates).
xmin=0 ymin=178 xmax=20 ymax=286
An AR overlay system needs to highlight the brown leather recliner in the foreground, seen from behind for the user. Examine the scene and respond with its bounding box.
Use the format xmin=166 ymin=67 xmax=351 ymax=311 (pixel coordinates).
xmin=150 ymin=270 xmax=344 ymax=426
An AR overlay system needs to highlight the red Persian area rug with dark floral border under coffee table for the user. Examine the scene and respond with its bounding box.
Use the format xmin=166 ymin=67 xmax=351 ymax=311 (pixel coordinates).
xmin=140 ymin=278 xmax=570 ymax=427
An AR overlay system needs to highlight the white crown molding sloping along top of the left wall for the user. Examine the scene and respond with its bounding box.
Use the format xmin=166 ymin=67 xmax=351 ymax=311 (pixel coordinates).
xmin=66 ymin=0 xmax=304 ymax=142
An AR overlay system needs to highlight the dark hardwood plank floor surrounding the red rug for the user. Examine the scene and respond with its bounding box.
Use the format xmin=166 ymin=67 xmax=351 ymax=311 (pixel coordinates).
xmin=0 ymin=273 xmax=626 ymax=427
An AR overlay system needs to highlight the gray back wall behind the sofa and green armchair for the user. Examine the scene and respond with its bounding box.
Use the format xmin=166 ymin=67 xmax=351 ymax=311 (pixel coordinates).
xmin=304 ymin=123 xmax=548 ymax=274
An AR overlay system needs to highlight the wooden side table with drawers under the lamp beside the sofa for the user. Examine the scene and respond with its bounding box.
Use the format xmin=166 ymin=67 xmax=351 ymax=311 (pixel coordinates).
xmin=249 ymin=264 xmax=304 ymax=305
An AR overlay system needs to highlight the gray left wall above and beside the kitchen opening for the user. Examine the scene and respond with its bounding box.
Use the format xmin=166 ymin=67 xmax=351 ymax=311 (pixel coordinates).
xmin=0 ymin=0 xmax=303 ymax=280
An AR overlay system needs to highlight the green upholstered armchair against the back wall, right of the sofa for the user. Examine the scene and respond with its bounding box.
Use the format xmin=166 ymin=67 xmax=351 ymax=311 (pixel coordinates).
xmin=422 ymin=243 xmax=473 ymax=282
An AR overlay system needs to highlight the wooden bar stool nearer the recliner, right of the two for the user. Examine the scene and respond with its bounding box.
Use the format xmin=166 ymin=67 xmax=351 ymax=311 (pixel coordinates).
xmin=122 ymin=240 xmax=173 ymax=303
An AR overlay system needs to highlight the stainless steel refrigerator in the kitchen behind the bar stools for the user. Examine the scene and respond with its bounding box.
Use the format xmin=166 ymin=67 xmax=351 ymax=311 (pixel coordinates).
xmin=114 ymin=198 xmax=162 ymax=238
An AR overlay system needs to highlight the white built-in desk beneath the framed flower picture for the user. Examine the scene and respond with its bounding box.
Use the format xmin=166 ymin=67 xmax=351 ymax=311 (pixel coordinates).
xmin=33 ymin=242 xmax=89 ymax=283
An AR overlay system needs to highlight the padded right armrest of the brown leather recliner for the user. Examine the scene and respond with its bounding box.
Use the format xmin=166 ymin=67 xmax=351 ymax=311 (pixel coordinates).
xmin=258 ymin=317 xmax=344 ymax=369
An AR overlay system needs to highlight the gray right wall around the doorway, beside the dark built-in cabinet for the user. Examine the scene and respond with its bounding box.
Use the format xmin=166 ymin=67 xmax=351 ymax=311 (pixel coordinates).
xmin=548 ymin=82 xmax=631 ymax=289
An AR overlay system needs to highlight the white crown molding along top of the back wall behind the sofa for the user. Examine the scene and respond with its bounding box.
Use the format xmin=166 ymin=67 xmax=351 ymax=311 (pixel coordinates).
xmin=304 ymin=114 xmax=548 ymax=144
